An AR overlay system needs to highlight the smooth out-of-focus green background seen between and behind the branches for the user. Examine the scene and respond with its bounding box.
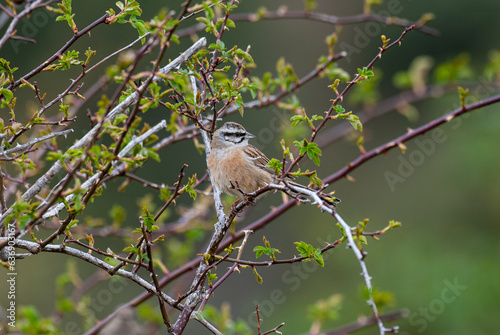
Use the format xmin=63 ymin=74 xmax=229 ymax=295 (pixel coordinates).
xmin=0 ymin=0 xmax=500 ymax=334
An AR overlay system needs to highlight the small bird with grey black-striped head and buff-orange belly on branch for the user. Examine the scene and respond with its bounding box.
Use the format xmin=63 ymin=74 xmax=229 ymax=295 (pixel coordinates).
xmin=208 ymin=122 xmax=276 ymax=200
